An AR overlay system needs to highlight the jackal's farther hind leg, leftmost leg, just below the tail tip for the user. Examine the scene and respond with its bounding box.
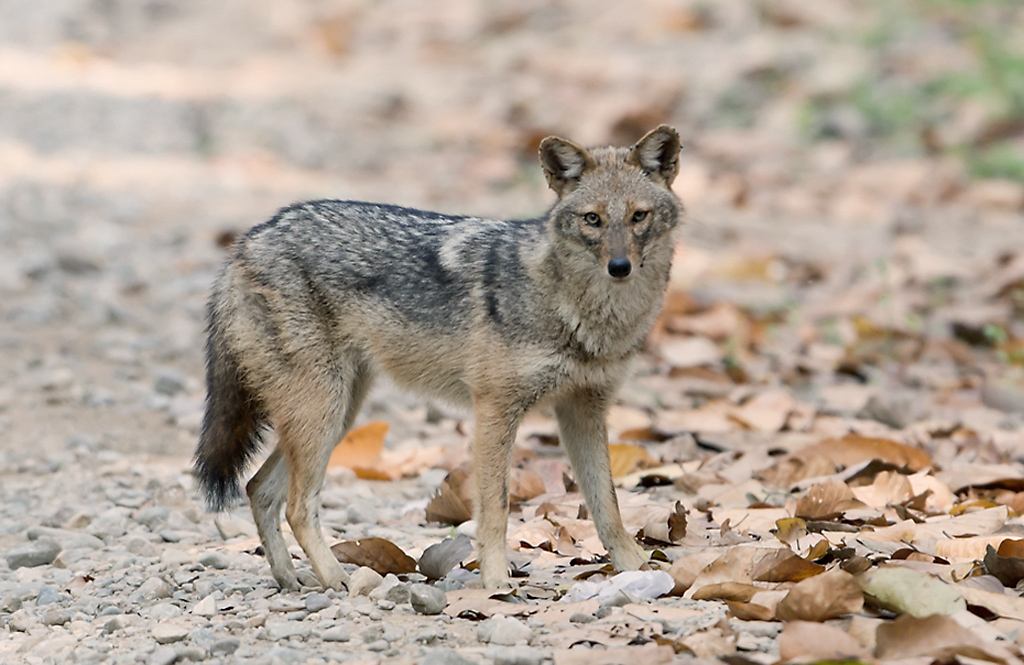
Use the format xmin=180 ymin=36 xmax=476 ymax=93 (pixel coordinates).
xmin=246 ymin=448 xmax=299 ymax=589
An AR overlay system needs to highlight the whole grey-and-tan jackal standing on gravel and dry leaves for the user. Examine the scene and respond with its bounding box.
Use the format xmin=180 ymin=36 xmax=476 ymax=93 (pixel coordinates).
xmin=195 ymin=125 xmax=681 ymax=588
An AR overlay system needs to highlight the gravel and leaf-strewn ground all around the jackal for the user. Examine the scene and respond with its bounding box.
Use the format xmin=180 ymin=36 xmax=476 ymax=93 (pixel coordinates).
xmin=0 ymin=0 xmax=1024 ymax=665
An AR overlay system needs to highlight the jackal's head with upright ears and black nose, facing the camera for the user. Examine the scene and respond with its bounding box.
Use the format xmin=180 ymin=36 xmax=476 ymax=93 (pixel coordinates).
xmin=540 ymin=125 xmax=681 ymax=281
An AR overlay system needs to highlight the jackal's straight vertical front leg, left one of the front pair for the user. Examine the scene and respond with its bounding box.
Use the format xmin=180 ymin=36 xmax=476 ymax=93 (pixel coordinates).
xmin=473 ymin=393 xmax=523 ymax=589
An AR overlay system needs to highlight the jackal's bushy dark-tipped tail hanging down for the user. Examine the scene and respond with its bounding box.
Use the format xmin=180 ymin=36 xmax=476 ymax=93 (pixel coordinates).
xmin=193 ymin=313 xmax=266 ymax=510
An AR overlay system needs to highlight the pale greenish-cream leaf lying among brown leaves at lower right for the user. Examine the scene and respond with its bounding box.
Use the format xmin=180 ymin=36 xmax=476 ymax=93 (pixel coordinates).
xmin=857 ymin=566 xmax=967 ymax=617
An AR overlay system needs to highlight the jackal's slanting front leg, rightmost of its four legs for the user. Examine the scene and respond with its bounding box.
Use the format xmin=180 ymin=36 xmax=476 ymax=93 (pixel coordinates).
xmin=555 ymin=389 xmax=647 ymax=571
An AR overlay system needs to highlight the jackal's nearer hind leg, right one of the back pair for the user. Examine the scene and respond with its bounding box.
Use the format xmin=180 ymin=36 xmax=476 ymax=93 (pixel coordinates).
xmin=280 ymin=365 xmax=372 ymax=589
